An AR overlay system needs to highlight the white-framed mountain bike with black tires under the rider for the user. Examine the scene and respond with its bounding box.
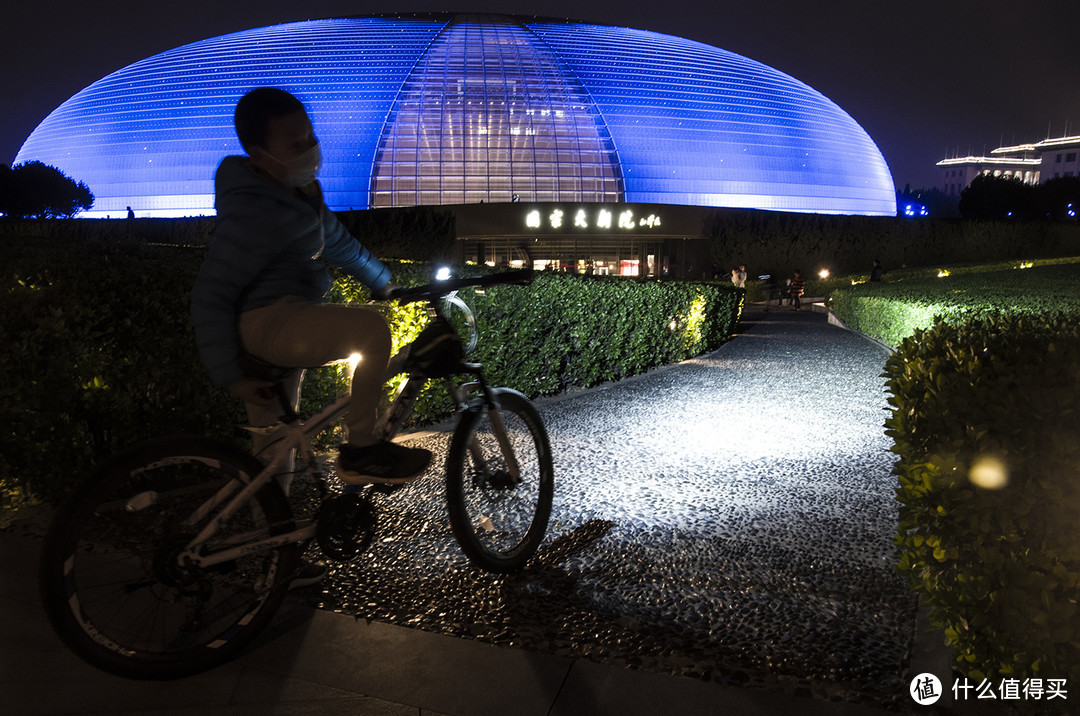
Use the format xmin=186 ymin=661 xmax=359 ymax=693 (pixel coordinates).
xmin=40 ymin=271 xmax=554 ymax=679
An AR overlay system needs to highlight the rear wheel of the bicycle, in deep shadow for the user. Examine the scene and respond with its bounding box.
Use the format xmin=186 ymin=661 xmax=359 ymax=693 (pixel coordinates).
xmin=40 ymin=436 xmax=299 ymax=679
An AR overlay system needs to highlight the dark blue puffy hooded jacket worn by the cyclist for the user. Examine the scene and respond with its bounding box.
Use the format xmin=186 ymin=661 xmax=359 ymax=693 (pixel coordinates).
xmin=191 ymin=157 xmax=390 ymax=388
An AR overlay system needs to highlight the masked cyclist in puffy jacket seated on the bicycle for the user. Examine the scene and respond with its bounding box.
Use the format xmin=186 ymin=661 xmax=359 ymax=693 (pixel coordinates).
xmin=191 ymin=87 xmax=432 ymax=487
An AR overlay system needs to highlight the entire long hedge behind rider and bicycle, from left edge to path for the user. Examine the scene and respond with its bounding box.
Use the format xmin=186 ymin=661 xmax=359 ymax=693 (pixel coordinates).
xmin=0 ymin=232 xmax=742 ymax=499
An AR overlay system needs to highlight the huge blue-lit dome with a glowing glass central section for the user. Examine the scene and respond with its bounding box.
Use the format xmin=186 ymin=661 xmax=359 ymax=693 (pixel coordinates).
xmin=15 ymin=14 xmax=896 ymax=216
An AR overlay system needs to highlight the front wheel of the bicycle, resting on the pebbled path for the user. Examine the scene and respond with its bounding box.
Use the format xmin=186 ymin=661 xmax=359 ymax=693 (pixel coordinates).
xmin=446 ymin=388 xmax=555 ymax=573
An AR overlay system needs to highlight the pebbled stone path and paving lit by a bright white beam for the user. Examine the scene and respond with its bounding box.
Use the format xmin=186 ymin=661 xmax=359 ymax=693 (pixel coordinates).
xmin=0 ymin=310 xmax=945 ymax=716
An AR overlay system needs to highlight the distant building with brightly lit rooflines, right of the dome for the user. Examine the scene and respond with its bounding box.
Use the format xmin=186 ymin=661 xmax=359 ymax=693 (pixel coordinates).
xmin=937 ymin=136 xmax=1080 ymax=197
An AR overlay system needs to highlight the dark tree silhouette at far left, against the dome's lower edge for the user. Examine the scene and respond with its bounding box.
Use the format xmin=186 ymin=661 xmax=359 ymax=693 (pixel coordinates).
xmin=0 ymin=162 xmax=94 ymax=218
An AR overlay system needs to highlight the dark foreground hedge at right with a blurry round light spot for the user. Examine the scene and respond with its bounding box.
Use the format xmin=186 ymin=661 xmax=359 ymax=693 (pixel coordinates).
xmin=886 ymin=313 xmax=1080 ymax=684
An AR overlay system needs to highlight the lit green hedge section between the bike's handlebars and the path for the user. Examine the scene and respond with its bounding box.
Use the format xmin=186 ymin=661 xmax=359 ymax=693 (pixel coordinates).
xmin=468 ymin=273 xmax=742 ymax=395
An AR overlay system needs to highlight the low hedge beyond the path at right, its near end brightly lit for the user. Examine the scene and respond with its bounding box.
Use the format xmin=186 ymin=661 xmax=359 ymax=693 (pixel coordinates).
xmin=829 ymin=258 xmax=1080 ymax=347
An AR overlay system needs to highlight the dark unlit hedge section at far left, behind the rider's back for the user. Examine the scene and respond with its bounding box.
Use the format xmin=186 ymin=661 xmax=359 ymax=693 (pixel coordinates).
xmin=0 ymin=239 xmax=236 ymax=497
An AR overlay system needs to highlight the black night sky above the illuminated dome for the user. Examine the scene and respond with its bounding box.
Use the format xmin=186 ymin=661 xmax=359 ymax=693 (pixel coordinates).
xmin=0 ymin=0 xmax=1080 ymax=189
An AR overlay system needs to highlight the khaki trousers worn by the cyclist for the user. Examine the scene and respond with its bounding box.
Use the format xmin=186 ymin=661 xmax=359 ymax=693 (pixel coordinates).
xmin=239 ymin=296 xmax=390 ymax=454
